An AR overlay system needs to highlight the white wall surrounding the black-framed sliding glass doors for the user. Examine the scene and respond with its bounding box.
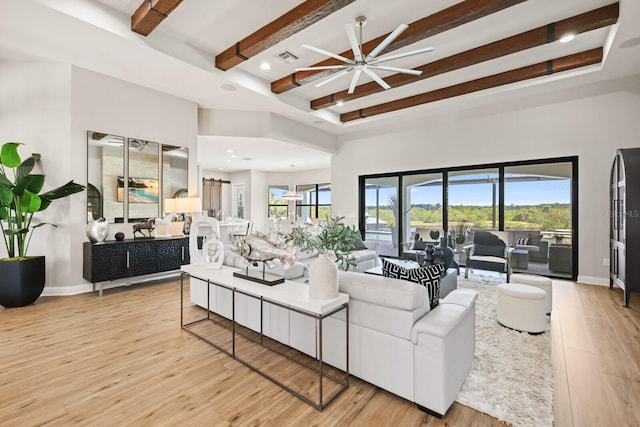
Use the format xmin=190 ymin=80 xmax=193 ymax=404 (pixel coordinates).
xmin=331 ymin=76 xmax=640 ymax=284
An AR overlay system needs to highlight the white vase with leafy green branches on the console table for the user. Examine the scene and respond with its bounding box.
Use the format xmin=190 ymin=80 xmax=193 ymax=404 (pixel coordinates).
xmin=287 ymin=216 xmax=361 ymax=299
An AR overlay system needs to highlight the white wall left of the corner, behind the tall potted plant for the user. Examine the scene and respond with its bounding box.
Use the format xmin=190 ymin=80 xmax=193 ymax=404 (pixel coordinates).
xmin=0 ymin=61 xmax=75 ymax=291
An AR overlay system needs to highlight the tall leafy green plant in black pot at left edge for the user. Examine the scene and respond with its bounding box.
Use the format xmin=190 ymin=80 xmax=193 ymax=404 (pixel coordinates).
xmin=0 ymin=142 xmax=85 ymax=307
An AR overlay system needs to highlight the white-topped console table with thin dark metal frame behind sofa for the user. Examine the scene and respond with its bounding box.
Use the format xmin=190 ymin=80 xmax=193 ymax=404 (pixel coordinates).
xmin=180 ymin=265 xmax=349 ymax=410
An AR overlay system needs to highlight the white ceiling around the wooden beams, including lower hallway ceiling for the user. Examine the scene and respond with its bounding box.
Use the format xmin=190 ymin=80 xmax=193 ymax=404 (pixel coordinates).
xmin=0 ymin=0 xmax=640 ymax=171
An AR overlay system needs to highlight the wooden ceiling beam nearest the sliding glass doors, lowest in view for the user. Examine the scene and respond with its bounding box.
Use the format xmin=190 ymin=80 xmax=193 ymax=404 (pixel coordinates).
xmin=340 ymin=47 xmax=604 ymax=122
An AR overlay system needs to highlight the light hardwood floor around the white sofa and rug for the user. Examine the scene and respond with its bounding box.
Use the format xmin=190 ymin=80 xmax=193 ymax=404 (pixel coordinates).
xmin=0 ymin=281 xmax=640 ymax=427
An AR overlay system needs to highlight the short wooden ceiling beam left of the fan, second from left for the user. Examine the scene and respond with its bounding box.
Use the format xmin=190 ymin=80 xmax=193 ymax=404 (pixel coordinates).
xmin=216 ymin=0 xmax=355 ymax=71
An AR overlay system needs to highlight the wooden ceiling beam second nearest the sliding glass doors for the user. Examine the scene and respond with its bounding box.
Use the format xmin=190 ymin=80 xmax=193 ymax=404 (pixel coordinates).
xmin=311 ymin=3 xmax=620 ymax=110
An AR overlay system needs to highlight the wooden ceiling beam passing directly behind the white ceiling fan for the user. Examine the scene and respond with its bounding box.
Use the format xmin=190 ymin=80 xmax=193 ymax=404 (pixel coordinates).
xmin=271 ymin=0 xmax=526 ymax=94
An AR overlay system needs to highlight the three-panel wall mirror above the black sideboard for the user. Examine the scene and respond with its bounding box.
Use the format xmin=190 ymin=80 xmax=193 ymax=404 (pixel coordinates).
xmin=87 ymin=131 xmax=189 ymax=223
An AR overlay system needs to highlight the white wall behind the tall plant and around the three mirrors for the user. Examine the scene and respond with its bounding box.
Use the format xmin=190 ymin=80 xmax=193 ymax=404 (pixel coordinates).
xmin=0 ymin=61 xmax=198 ymax=295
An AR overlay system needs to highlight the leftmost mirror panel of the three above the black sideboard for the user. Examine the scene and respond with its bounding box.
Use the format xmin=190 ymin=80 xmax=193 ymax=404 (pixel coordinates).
xmin=87 ymin=131 xmax=125 ymax=223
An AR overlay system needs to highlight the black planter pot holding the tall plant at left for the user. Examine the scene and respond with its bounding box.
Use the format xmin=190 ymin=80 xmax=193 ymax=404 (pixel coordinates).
xmin=0 ymin=256 xmax=45 ymax=308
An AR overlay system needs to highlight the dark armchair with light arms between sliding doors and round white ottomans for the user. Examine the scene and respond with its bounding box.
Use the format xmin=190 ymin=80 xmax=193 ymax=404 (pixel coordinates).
xmin=464 ymin=230 xmax=511 ymax=283
